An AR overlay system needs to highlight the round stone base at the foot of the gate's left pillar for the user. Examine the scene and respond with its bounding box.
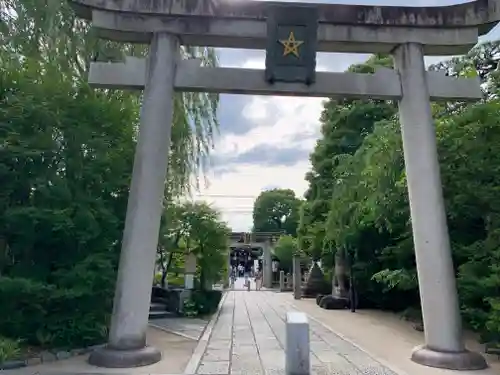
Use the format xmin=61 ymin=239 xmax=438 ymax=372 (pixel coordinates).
xmin=89 ymin=346 xmax=161 ymax=368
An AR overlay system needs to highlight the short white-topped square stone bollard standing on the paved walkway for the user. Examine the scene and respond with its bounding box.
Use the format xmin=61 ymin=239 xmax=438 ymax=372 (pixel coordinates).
xmin=285 ymin=311 xmax=311 ymax=375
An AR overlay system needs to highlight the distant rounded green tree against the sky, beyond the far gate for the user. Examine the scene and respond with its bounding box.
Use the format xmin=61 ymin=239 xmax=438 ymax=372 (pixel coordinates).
xmin=253 ymin=189 xmax=302 ymax=235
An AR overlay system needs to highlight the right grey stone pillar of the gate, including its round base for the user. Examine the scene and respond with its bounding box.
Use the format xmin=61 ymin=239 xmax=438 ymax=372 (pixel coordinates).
xmin=394 ymin=43 xmax=486 ymax=370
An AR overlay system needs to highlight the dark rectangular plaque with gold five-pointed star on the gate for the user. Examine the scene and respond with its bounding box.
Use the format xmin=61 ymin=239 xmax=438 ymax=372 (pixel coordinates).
xmin=265 ymin=4 xmax=318 ymax=85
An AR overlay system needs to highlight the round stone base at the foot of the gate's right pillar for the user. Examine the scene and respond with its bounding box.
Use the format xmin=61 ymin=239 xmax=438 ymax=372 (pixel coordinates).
xmin=411 ymin=345 xmax=488 ymax=371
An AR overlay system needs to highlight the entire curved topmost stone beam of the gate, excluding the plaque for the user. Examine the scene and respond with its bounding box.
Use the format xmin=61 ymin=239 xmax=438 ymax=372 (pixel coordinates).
xmin=69 ymin=0 xmax=500 ymax=56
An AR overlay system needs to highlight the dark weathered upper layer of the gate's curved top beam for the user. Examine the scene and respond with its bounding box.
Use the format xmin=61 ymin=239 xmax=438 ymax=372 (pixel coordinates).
xmin=71 ymin=0 xmax=500 ymax=33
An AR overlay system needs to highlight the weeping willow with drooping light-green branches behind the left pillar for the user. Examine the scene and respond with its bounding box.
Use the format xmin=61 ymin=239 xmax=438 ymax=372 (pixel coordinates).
xmin=0 ymin=0 xmax=218 ymax=195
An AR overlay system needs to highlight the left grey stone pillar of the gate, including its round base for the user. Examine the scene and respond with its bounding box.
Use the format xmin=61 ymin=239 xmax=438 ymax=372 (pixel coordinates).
xmin=89 ymin=33 xmax=179 ymax=368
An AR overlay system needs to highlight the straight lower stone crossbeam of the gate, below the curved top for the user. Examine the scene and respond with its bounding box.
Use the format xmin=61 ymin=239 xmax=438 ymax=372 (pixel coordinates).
xmin=88 ymin=57 xmax=483 ymax=101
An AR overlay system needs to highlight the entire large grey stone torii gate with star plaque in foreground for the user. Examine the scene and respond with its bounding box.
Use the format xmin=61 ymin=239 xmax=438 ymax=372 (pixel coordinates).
xmin=71 ymin=0 xmax=500 ymax=370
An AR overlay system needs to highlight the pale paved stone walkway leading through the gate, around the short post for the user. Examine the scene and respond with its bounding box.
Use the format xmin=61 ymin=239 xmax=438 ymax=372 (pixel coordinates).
xmin=196 ymin=291 xmax=395 ymax=375
